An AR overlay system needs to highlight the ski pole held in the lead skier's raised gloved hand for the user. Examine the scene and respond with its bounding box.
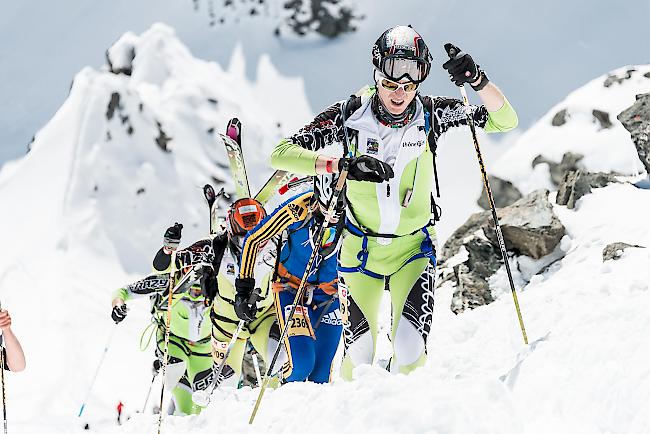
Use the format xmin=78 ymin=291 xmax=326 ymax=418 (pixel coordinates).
xmin=445 ymin=43 xmax=528 ymax=345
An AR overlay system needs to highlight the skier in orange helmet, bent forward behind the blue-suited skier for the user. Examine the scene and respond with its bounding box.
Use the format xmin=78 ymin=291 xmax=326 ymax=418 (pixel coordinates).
xmin=152 ymin=198 xmax=285 ymax=387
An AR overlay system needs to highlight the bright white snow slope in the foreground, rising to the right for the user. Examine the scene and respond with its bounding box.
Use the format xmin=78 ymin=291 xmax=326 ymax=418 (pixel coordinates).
xmin=102 ymin=185 xmax=650 ymax=434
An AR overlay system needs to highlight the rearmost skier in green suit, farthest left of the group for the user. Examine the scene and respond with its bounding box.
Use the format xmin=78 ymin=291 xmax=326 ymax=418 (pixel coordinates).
xmin=111 ymin=223 xmax=216 ymax=414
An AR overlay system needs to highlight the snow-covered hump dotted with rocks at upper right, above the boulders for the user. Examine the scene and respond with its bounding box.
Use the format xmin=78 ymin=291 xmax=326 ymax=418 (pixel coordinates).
xmin=492 ymin=65 xmax=650 ymax=194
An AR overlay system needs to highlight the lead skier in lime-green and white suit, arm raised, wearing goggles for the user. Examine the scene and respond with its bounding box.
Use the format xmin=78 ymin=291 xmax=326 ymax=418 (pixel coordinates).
xmin=271 ymin=26 xmax=517 ymax=379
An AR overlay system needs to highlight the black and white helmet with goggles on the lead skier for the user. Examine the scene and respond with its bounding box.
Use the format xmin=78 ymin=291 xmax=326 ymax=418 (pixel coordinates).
xmin=372 ymin=26 xmax=433 ymax=83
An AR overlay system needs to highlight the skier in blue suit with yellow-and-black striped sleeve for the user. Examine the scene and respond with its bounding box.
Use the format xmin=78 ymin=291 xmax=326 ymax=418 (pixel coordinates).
xmin=235 ymin=191 xmax=343 ymax=383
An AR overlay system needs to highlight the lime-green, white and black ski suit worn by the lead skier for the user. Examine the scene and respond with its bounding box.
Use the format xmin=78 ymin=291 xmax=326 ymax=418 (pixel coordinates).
xmin=271 ymin=87 xmax=517 ymax=379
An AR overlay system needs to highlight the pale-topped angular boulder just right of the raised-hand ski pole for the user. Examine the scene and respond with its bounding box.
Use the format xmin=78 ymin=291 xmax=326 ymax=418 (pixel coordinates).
xmin=484 ymin=190 xmax=565 ymax=259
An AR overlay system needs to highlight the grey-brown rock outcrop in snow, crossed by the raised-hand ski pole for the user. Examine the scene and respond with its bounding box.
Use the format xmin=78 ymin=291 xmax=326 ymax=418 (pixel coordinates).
xmin=439 ymin=190 xmax=565 ymax=313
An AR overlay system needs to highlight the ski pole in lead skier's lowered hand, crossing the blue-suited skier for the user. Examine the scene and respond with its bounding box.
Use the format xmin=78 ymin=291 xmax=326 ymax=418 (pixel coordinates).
xmin=248 ymin=159 xmax=350 ymax=425
